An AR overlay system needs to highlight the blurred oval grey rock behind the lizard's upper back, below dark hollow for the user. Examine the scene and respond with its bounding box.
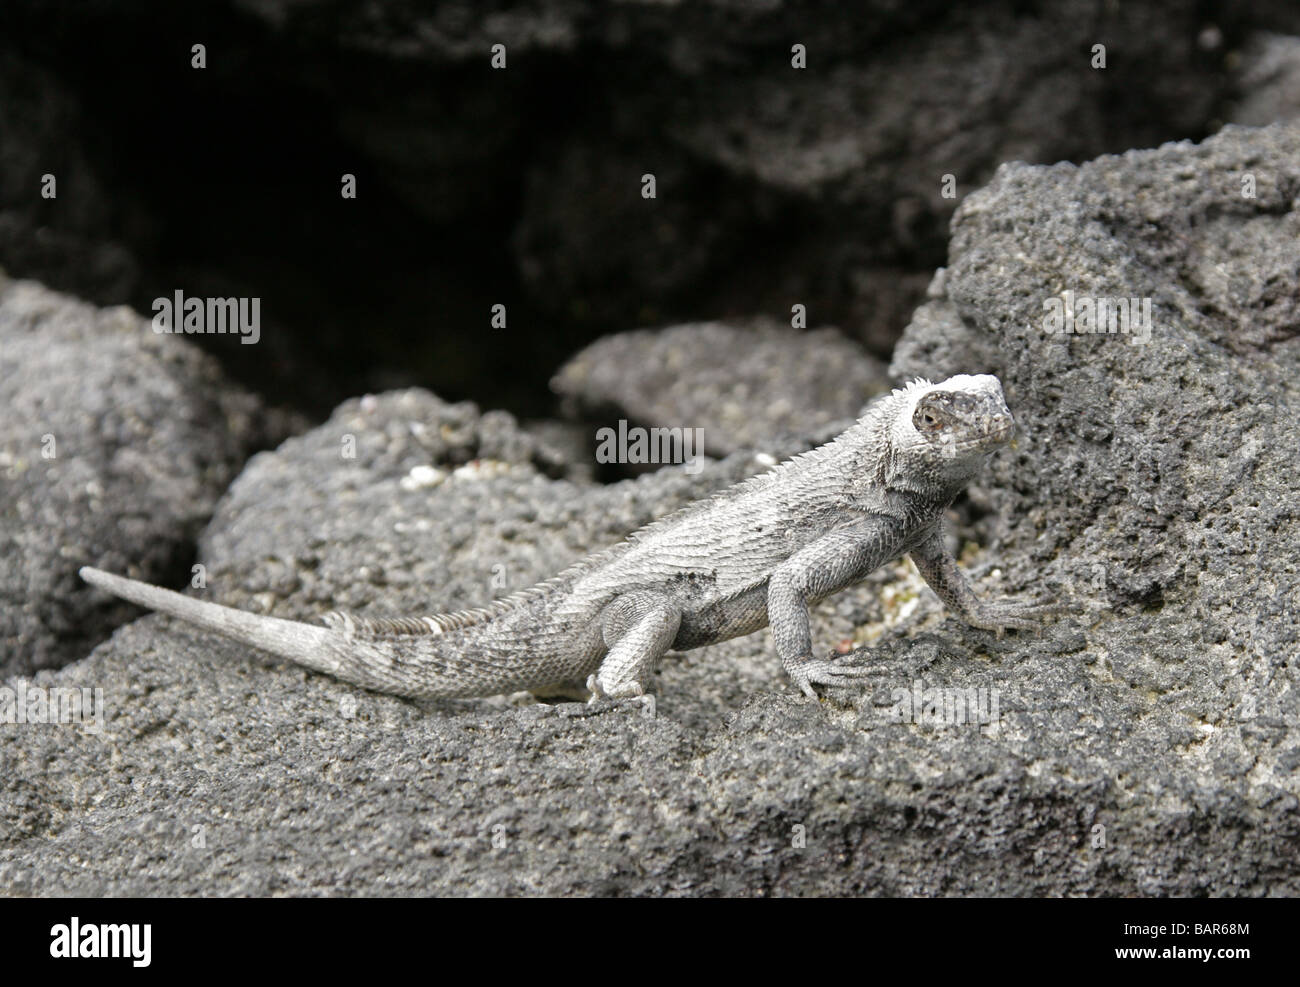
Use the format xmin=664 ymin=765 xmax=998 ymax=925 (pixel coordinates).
xmin=551 ymin=320 xmax=889 ymax=455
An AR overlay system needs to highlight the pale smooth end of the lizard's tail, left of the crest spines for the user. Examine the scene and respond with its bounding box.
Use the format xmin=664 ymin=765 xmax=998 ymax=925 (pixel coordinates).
xmin=81 ymin=566 xmax=342 ymax=675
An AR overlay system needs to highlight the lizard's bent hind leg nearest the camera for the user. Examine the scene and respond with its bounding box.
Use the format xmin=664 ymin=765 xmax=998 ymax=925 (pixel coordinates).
xmin=586 ymin=593 xmax=681 ymax=702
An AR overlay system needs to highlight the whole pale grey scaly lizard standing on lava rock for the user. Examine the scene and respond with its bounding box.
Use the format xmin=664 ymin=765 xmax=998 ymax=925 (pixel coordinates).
xmin=82 ymin=375 xmax=1054 ymax=700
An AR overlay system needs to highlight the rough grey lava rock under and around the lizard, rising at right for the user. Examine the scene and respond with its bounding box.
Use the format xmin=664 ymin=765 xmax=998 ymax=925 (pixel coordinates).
xmin=0 ymin=126 xmax=1300 ymax=895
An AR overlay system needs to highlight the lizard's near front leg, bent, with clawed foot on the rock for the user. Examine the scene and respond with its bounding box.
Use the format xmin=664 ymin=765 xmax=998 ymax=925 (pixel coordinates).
xmin=767 ymin=515 xmax=901 ymax=698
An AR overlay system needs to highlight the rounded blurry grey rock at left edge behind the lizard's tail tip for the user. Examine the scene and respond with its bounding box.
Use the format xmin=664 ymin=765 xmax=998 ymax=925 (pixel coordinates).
xmin=0 ymin=272 xmax=290 ymax=674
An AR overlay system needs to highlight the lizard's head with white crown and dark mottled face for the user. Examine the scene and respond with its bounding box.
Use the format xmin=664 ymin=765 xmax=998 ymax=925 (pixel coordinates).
xmin=894 ymin=373 xmax=1015 ymax=476
